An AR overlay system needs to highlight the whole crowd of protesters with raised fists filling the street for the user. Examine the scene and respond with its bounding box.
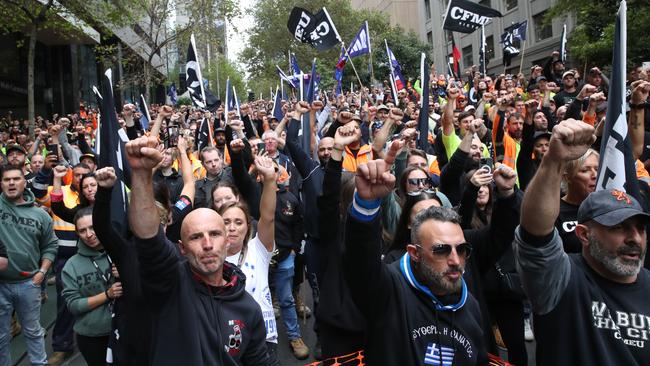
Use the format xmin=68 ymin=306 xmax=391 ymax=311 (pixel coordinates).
xmin=0 ymin=52 xmax=650 ymax=366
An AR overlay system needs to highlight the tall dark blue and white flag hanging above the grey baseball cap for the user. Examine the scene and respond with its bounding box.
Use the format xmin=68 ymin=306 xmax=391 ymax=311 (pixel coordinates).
xmin=596 ymin=0 xmax=640 ymax=200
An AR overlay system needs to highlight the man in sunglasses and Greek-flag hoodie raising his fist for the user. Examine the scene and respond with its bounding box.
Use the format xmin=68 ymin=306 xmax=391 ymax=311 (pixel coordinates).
xmin=343 ymin=141 xmax=487 ymax=365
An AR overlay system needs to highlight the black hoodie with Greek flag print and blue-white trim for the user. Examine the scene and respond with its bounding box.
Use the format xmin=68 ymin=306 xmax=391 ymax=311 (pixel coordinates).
xmin=343 ymin=199 xmax=487 ymax=365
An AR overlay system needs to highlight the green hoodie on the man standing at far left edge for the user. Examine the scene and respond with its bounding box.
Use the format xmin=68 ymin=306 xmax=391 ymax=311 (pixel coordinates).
xmin=0 ymin=189 xmax=59 ymax=283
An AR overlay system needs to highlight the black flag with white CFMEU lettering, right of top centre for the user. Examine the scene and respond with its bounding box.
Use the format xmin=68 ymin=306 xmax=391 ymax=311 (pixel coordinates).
xmin=442 ymin=0 xmax=503 ymax=33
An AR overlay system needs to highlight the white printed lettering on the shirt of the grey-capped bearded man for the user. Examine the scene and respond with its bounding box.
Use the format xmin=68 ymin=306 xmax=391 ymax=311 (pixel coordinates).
xmin=591 ymin=301 xmax=650 ymax=348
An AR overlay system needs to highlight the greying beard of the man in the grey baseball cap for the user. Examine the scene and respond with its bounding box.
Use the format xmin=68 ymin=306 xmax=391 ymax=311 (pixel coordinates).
xmin=588 ymin=234 xmax=647 ymax=277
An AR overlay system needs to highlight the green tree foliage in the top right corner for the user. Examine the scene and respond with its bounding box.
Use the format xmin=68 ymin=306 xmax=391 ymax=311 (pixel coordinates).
xmin=545 ymin=0 xmax=650 ymax=67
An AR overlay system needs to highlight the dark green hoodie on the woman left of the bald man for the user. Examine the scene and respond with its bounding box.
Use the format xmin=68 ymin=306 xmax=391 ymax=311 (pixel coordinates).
xmin=61 ymin=240 xmax=114 ymax=337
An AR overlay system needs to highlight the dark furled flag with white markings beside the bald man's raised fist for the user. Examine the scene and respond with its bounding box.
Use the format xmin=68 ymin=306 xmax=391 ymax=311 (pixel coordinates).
xmin=93 ymin=69 xmax=131 ymax=237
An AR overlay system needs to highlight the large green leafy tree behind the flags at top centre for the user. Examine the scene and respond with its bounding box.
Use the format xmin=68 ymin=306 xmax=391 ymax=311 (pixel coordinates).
xmin=241 ymin=0 xmax=431 ymax=93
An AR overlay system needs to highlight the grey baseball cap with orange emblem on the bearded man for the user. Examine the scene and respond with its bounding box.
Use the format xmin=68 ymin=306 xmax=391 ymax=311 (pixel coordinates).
xmin=578 ymin=189 xmax=650 ymax=226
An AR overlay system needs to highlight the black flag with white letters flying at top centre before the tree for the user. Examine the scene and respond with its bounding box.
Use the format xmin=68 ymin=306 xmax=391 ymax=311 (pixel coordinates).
xmin=287 ymin=7 xmax=341 ymax=52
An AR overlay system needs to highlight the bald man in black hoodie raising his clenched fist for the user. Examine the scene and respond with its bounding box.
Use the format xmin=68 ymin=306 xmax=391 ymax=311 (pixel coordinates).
xmin=126 ymin=136 xmax=267 ymax=365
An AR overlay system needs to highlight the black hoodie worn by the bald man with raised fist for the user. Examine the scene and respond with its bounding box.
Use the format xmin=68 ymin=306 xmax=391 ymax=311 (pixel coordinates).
xmin=135 ymin=230 xmax=267 ymax=366
